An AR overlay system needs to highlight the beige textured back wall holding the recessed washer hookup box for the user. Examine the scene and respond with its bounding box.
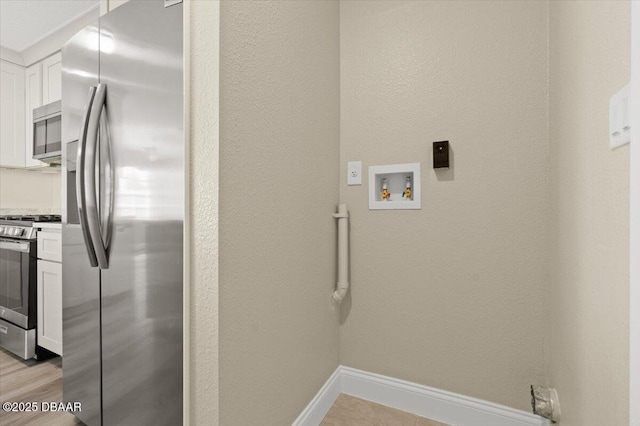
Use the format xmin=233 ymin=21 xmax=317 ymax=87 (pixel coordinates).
xmin=340 ymin=1 xmax=548 ymax=411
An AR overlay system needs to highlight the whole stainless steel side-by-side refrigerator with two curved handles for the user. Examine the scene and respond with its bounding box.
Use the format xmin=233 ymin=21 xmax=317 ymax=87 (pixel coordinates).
xmin=62 ymin=0 xmax=185 ymax=425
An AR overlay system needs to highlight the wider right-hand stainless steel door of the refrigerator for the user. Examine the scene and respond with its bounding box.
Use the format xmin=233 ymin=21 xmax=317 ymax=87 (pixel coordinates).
xmin=100 ymin=0 xmax=185 ymax=425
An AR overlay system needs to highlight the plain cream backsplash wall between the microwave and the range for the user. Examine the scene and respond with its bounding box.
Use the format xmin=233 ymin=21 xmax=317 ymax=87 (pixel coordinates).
xmin=0 ymin=169 xmax=62 ymax=214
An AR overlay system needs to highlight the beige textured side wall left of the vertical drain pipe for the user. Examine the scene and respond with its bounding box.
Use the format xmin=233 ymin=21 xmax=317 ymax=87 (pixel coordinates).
xmin=219 ymin=1 xmax=340 ymax=426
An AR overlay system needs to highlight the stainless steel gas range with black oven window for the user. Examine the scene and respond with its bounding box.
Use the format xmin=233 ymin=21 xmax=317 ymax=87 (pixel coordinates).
xmin=0 ymin=215 xmax=60 ymax=359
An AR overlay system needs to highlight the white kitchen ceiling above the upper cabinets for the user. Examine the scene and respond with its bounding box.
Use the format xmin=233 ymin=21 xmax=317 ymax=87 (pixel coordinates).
xmin=0 ymin=0 xmax=99 ymax=52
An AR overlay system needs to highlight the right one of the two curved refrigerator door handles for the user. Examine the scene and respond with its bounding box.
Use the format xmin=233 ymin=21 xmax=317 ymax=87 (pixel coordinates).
xmin=84 ymin=84 xmax=109 ymax=269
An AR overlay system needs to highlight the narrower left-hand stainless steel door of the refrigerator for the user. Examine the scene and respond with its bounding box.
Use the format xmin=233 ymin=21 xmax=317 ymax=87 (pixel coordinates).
xmin=62 ymin=18 xmax=101 ymax=426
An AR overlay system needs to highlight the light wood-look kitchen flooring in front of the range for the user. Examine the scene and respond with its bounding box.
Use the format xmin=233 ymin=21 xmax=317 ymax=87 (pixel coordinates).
xmin=0 ymin=349 xmax=83 ymax=426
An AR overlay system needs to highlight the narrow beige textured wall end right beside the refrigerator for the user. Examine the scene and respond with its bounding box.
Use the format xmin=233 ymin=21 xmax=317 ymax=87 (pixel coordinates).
xmin=185 ymin=0 xmax=220 ymax=426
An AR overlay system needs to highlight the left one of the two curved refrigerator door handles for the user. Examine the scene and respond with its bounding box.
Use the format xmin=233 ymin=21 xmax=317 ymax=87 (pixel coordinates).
xmin=76 ymin=86 xmax=98 ymax=267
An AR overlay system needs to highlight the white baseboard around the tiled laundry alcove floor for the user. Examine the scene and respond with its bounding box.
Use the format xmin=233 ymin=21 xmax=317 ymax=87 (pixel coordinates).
xmin=293 ymin=366 xmax=550 ymax=426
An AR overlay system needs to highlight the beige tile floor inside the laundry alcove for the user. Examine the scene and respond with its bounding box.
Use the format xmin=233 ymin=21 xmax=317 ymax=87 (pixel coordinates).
xmin=320 ymin=393 xmax=448 ymax=426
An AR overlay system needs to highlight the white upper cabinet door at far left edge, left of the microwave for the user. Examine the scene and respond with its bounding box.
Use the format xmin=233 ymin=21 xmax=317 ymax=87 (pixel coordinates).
xmin=0 ymin=61 xmax=25 ymax=167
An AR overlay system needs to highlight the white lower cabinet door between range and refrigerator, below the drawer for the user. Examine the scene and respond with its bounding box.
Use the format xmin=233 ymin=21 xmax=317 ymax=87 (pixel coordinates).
xmin=36 ymin=260 xmax=62 ymax=355
